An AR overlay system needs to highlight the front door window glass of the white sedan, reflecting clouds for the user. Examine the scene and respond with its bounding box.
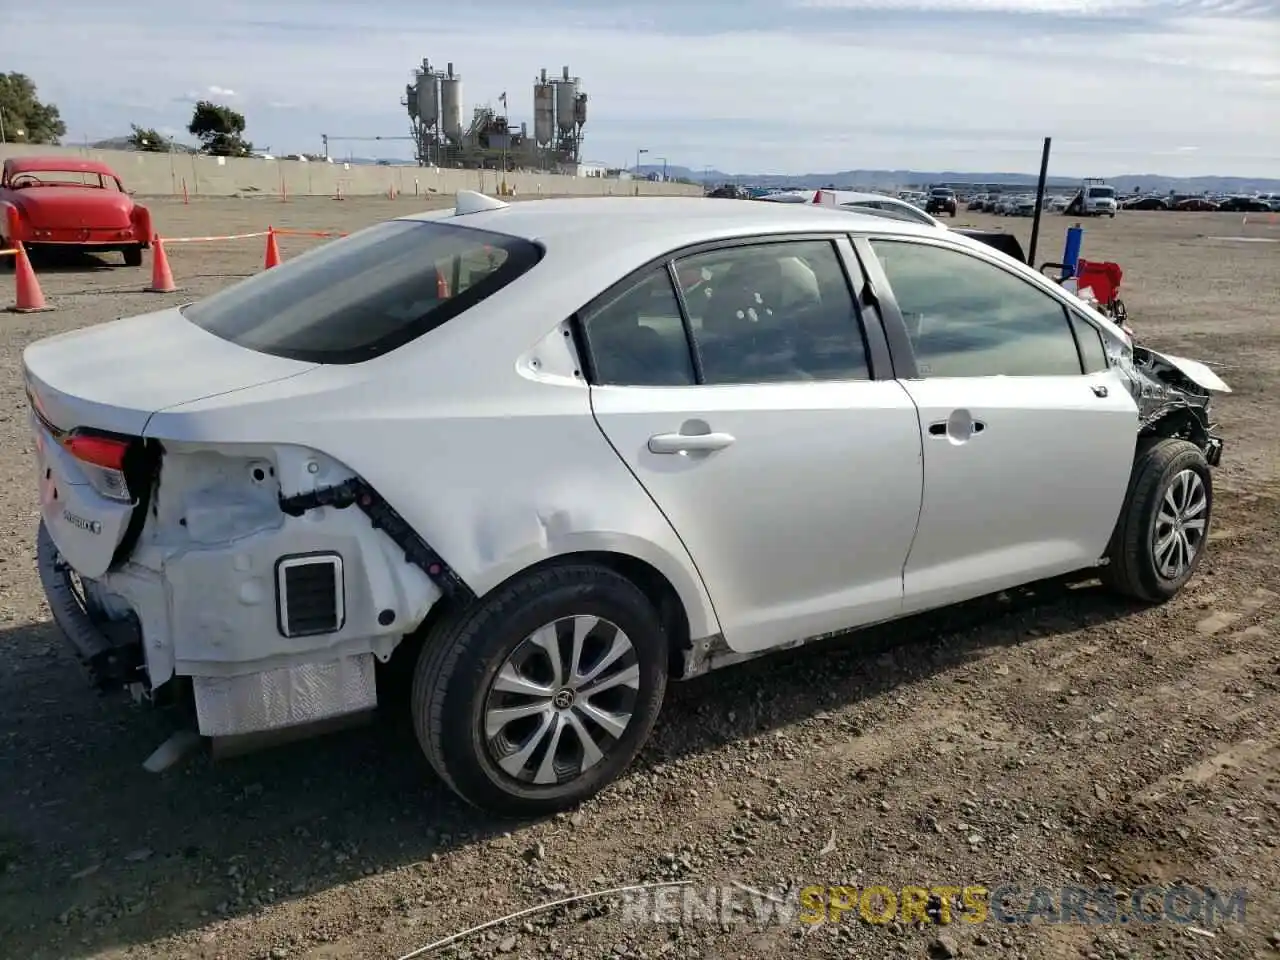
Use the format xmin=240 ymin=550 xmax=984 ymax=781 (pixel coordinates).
xmin=872 ymin=241 xmax=1082 ymax=378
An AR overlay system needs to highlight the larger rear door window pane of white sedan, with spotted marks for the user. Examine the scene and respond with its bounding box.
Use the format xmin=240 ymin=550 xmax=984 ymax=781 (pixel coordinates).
xmin=676 ymin=241 xmax=870 ymax=384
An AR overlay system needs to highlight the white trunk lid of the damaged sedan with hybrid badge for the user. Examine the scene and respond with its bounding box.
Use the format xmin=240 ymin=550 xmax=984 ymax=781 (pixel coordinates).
xmin=23 ymin=308 xmax=316 ymax=579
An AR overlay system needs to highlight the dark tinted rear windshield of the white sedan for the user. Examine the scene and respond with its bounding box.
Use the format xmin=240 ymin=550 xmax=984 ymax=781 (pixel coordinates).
xmin=183 ymin=220 xmax=541 ymax=364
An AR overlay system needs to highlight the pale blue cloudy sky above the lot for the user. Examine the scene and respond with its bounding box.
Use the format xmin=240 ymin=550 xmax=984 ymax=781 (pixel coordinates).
xmin=0 ymin=0 xmax=1280 ymax=178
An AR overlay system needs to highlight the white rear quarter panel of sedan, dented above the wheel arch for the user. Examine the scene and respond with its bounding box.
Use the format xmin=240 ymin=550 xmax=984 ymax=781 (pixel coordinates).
xmin=146 ymin=257 xmax=719 ymax=639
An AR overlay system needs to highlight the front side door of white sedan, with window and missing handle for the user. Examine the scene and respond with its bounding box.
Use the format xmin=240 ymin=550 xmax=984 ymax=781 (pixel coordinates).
xmin=859 ymin=238 xmax=1138 ymax=609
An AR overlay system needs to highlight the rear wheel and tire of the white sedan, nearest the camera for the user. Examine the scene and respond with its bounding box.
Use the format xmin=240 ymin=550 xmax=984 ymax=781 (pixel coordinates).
xmin=412 ymin=563 xmax=668 ymax=817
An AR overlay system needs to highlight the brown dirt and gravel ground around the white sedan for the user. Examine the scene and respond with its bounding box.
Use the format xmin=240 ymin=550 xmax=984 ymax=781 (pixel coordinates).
xmin=0 ymin=200 xmax=1280 ymax=960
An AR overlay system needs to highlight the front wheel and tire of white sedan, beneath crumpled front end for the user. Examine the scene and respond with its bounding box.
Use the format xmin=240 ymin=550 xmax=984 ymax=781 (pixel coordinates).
xmin=1102 ymin=438 xmax=1213 ymax=603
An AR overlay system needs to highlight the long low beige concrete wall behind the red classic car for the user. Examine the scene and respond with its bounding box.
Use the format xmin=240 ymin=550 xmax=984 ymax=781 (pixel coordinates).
xmin=0 ymin=143 xmax=703 ymax=197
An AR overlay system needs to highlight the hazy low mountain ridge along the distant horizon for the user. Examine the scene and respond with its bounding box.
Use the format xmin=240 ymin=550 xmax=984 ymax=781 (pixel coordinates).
xmin=634 ymin=164 xmax=1280 ymax=193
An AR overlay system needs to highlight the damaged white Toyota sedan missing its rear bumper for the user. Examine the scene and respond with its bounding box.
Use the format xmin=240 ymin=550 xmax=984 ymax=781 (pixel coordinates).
xmin=23 ymin=195 xmax=1228 ymax=814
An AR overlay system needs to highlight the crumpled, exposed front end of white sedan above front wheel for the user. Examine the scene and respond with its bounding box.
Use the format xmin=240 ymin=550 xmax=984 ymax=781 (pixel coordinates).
xmin=1112 ymin=346 xmax=1231 ymax=466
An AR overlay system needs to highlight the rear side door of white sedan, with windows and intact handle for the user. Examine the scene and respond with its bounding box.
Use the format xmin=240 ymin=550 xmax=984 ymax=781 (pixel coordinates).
xmin=581 ymin=237 xmax=922 ymax=652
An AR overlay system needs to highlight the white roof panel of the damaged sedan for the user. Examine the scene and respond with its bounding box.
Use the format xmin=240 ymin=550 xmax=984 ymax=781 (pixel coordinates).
xmin=399 ymin=197 xmax=936 ymax=256
